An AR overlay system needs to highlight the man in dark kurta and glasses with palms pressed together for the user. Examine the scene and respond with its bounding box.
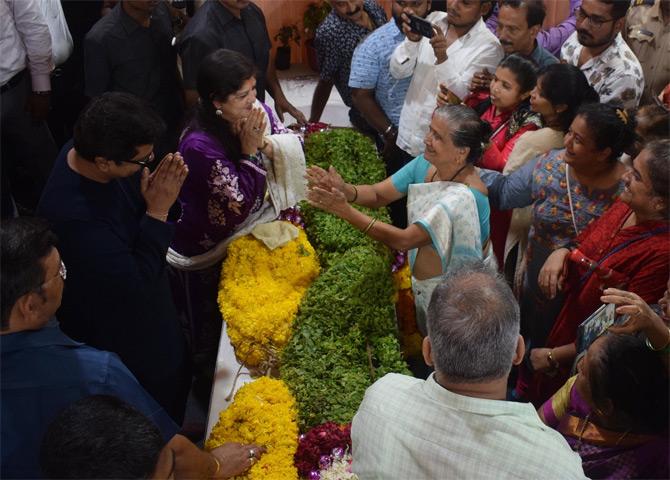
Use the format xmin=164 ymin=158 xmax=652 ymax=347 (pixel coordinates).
xmin=38 ymin=92 xmax=191 ymax=424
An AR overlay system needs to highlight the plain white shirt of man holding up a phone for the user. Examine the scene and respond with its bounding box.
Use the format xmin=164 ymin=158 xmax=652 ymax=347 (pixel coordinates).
xmin=390 ymin=12 xmax=504 ymax=156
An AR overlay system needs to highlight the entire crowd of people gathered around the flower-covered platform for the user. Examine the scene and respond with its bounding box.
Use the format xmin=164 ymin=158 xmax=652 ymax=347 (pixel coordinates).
xmin=0 ymin=0 xmax=670 ymax=479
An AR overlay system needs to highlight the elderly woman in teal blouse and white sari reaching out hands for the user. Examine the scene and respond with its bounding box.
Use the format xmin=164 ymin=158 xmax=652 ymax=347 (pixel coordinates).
xmin=307 ymin=105 xmax=494 ymax=335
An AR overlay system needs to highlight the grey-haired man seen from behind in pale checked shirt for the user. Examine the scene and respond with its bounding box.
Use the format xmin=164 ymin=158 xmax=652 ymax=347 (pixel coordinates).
xmin=351 ymin=264 xmax=586 ymax=480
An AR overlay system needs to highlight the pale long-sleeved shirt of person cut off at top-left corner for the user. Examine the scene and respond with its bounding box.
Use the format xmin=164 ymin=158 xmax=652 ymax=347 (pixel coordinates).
xmin=0 ymin=0 xmax=53 ymax=92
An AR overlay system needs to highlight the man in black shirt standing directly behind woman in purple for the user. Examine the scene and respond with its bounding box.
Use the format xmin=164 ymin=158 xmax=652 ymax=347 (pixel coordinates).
xmin=179 ymin=0 xmax=305 ymax=123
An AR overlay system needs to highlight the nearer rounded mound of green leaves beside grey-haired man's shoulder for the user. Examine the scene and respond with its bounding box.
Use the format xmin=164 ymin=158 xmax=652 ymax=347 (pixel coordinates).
xmin=280 ymin=246 xmax=408 ymax=431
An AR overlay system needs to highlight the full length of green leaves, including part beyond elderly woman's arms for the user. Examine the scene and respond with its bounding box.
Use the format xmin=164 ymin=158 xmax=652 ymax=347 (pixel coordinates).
xmin=280 ymin=129 xmax=409 ymax=431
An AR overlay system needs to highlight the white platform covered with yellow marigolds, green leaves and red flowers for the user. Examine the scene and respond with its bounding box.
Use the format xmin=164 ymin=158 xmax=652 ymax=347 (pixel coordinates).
xmin=206 ymin=129 xmax=409 ymax=480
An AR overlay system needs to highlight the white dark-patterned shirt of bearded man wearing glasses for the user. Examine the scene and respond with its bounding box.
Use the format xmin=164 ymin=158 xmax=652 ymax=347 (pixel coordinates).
xmin=561 ymin=32 xmax=644 ymax=108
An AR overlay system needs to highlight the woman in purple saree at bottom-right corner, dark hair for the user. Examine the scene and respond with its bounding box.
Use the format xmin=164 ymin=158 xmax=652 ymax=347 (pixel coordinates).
xmin=538 ymin=334 xmax=670 ymax=478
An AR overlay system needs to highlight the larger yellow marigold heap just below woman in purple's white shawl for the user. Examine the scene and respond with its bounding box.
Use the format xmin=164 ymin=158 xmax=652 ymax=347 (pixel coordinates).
xmin=219 ymin=229 xmax=320 ymax=370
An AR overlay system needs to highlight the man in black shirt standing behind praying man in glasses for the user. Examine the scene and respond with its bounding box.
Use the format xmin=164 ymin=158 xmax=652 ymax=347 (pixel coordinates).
xmin=84 ymin=0 xmax=184 ymax=158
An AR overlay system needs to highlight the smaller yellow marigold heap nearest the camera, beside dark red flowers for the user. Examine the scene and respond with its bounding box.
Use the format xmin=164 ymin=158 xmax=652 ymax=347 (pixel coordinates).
xmin=205 ymin=377 xmax=298 ymax=480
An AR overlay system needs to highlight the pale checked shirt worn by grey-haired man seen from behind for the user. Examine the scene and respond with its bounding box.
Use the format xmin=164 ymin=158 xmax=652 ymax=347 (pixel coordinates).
xmin=351 ymin=373 xmax=586 ymax=480
